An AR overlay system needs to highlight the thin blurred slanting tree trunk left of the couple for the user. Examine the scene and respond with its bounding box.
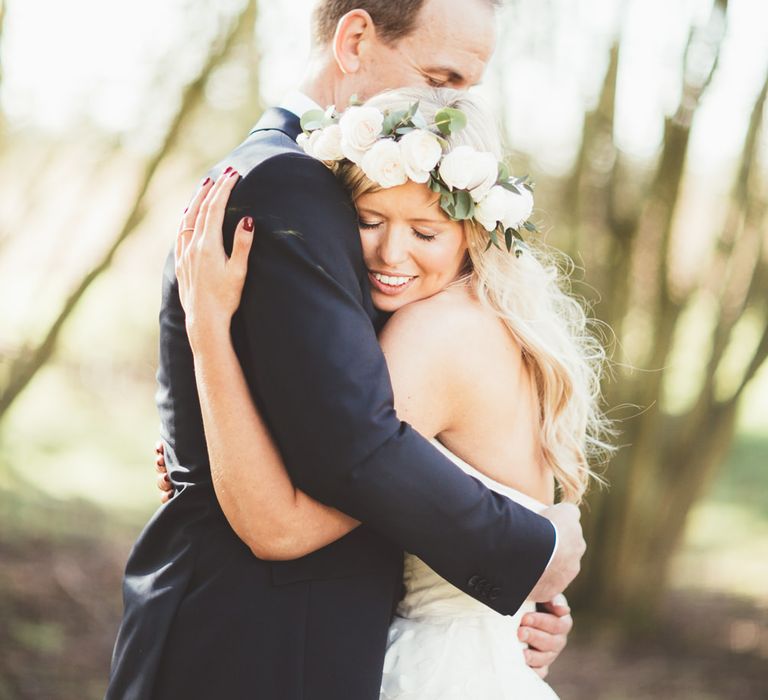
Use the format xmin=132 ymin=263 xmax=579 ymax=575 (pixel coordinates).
xmin=0 ymin=0 xmax=258 ymax=422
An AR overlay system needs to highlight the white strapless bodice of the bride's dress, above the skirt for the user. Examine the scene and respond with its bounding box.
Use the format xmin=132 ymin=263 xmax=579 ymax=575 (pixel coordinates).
xmin=397 ymin=440 xmax=547 ymax=619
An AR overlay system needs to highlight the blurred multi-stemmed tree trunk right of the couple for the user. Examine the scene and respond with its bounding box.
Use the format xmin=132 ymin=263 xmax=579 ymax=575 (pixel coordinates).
xmin=564 ymin=0 xmax=768 ymax=624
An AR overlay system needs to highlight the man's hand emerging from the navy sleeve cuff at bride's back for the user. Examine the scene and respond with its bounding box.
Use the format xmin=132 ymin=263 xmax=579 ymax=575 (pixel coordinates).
xmin=529 ymin=503 xmax=587 ymax=603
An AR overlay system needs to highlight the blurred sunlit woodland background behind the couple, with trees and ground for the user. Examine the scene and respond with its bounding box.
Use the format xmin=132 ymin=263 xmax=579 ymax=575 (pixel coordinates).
xmin=0 ymin=0 xmax=768 ymax=700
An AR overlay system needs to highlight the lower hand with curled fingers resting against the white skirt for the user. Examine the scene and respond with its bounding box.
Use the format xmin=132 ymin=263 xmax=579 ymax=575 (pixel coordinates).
xmin=517 ymin=595 xmax=573 ymax=678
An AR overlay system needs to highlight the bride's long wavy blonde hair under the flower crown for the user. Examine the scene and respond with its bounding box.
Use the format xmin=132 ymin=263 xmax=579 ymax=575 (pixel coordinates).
xmin=331 ymin=88 xmax=615 ymax=503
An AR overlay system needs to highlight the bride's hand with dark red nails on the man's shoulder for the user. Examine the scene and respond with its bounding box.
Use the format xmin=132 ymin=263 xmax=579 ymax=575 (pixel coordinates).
xmin=176 ymin=169 xmax=253 ymax=348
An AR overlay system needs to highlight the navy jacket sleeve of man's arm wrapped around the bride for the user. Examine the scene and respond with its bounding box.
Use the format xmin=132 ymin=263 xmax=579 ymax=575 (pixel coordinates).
xmin=225 ymin=153 xmax=555 ymax=614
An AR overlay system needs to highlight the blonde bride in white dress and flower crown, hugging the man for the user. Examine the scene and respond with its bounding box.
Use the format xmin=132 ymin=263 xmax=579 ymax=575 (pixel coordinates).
xmin=176 ymin=89 xmax=610 ymax=700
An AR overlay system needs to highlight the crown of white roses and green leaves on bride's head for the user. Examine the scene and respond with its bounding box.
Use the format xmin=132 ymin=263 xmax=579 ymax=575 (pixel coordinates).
xmin=297 ymin=102 xmax=537 ymax=257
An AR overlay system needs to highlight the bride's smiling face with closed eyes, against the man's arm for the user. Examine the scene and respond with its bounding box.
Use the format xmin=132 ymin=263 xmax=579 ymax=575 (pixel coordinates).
xmin=355 ymin=181 xmax=467 ymax=312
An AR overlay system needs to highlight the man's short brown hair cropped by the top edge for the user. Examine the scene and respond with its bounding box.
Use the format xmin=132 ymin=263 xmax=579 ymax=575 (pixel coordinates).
xmin=313 ymin=0 xmax=501 ymax=46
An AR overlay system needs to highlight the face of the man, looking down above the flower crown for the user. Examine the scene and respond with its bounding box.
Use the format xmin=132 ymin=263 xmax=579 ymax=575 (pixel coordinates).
xmin=356 ymin=0 xmax=496 ymax=98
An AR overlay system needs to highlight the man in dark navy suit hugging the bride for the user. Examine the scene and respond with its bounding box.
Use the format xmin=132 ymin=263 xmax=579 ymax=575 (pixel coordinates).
xmin=107 ymin=0 xmax=584 ymax=700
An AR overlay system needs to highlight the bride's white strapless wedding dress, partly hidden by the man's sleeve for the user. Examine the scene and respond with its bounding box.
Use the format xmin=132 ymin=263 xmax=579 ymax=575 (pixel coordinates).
xmin=380 ymin=440 xmax=557 ymax=700
